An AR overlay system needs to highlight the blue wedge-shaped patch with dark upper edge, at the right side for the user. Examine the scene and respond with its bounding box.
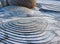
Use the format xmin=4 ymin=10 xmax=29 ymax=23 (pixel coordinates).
xmin=40 ymin=9 xmax=60 ymax=21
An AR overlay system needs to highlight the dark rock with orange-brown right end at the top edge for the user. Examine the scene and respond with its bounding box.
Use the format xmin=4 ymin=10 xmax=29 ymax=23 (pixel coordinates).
xmin=1 ymin=0 xmax=36 ymax=8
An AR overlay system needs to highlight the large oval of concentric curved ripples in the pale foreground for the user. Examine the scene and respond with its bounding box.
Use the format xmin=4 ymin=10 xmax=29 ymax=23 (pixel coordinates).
xmin=0 ymin=18 xmax=55 ymax=44
